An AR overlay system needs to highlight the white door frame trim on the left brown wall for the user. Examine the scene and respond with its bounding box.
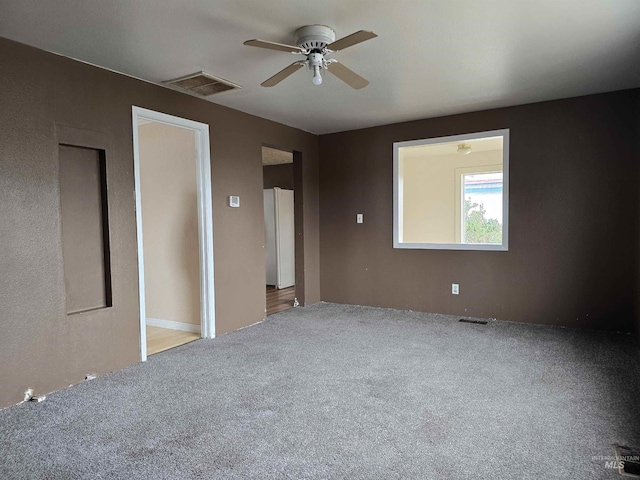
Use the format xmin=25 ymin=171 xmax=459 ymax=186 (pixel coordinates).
xmin=132 ymin=105 xmax=216 ymax=362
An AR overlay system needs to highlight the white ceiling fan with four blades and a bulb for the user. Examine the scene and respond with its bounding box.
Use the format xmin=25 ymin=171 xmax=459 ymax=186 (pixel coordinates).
xmin=244 ymin=25 xmax=377 ymax=89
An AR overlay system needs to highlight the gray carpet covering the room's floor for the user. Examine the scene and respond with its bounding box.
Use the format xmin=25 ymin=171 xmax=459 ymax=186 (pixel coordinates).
xmin=0 ymin=303 xmax=640 ymax=479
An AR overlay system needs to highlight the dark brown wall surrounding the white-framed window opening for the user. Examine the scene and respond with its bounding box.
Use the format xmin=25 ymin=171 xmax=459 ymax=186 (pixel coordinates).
xmin=320 ymin=90 xmax=640 ymax=331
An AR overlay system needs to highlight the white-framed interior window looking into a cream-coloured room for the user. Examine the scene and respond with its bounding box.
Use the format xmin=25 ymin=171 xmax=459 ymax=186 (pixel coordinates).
xmin=393 ymin=130 xmax=509 ymax=250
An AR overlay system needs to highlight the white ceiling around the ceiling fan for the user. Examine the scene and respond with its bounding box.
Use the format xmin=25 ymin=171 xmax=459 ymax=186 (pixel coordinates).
xmin=0 ymin=0 xmax=640 ymax=133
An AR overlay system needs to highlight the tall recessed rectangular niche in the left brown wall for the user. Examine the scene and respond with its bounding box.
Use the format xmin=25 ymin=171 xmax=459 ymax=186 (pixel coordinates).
xmin=59 ymin=145 xmax=111 ymax=314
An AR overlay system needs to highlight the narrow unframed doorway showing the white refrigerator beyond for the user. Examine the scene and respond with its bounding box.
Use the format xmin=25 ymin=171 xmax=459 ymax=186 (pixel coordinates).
xmin=262 ymin=146 xmax=298 ymax=316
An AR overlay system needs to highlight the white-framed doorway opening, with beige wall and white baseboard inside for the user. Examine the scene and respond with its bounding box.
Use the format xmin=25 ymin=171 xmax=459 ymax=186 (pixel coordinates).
xmin=133 ymin=106 xmax=215 ymax=361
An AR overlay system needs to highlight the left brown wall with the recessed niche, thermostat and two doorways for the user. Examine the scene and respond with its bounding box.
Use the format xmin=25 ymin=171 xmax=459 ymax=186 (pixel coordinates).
xmin=0 ymin=39 xmax=320 ymax=407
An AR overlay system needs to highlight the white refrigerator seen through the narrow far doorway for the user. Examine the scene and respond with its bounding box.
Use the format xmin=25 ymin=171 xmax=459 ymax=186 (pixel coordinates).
xmin=264 ymin=187 xmax=296 ymax=288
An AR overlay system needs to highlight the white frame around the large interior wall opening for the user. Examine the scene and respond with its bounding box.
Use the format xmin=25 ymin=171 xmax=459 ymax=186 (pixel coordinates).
xmin=393 ymin=128 xmax=509 ymax=252
